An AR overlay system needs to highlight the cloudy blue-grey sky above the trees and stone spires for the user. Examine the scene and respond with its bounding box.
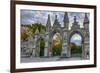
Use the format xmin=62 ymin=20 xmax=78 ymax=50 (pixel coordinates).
xmin=20 ymin=9 xmax=90 ymax=27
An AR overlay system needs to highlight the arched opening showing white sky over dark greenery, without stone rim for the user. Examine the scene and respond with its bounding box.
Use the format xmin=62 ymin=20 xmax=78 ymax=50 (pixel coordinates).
xmin=70 ymin=33 xmax=83 ymax=57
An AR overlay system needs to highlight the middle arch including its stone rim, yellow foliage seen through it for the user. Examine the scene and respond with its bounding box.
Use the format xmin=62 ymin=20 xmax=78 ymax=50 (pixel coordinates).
xmin=51 ymin=29 xmax=62 ymax=56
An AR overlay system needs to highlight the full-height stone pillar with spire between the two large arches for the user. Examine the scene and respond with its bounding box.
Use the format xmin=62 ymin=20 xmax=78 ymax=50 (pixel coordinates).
xmin=61 ymin=12 xmax=70 ymax=57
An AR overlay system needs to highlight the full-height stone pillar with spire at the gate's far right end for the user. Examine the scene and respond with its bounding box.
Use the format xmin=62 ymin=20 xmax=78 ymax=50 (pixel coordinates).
xmin=83 ymin=13 xmax=90 ymax=59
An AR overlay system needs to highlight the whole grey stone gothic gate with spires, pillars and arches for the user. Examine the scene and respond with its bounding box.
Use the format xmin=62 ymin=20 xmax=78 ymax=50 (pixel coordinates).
xmin=22 ymin=12 xmax=89 ymax=59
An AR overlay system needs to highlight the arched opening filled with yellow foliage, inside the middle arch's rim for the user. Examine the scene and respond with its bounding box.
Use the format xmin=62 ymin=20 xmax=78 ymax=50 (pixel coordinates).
xmin=52 ymin=32 xmax=62 ymax=56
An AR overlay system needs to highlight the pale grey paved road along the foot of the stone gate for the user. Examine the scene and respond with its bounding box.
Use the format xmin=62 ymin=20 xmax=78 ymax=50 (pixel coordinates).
xmin=21 ymin=57 xmax=85 ymax=63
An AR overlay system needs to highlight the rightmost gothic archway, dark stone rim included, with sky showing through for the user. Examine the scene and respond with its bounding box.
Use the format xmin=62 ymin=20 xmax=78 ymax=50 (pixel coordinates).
xmin=68 ymin=31 xmax=84 ymax=57
